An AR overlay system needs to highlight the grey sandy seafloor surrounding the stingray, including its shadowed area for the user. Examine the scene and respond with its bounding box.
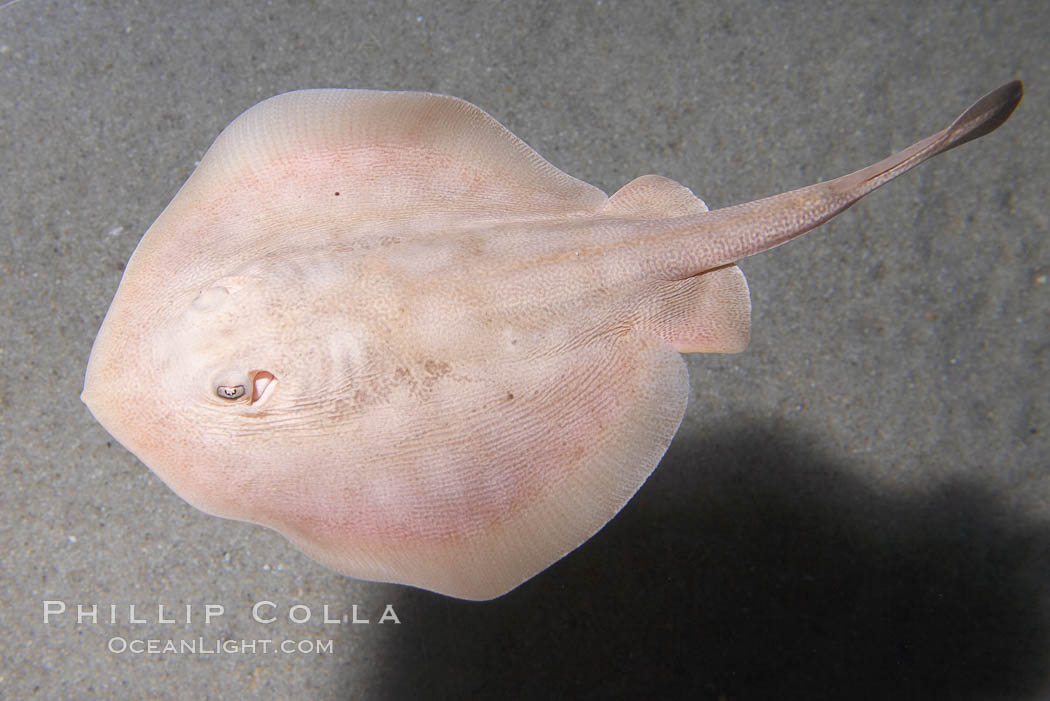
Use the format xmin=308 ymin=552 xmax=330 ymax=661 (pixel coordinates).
xmin=0 ymin=0 xmax=1050 ymax=699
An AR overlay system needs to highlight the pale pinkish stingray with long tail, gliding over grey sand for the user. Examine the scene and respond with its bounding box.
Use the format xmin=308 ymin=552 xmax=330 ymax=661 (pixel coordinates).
xmin=83 ymin=83 xmax=1022 ymax=599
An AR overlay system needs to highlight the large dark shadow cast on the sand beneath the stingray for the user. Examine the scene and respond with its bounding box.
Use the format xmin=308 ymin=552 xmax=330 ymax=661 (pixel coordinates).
xmin=347 ymin=427 xmax=1050 ymax=699
